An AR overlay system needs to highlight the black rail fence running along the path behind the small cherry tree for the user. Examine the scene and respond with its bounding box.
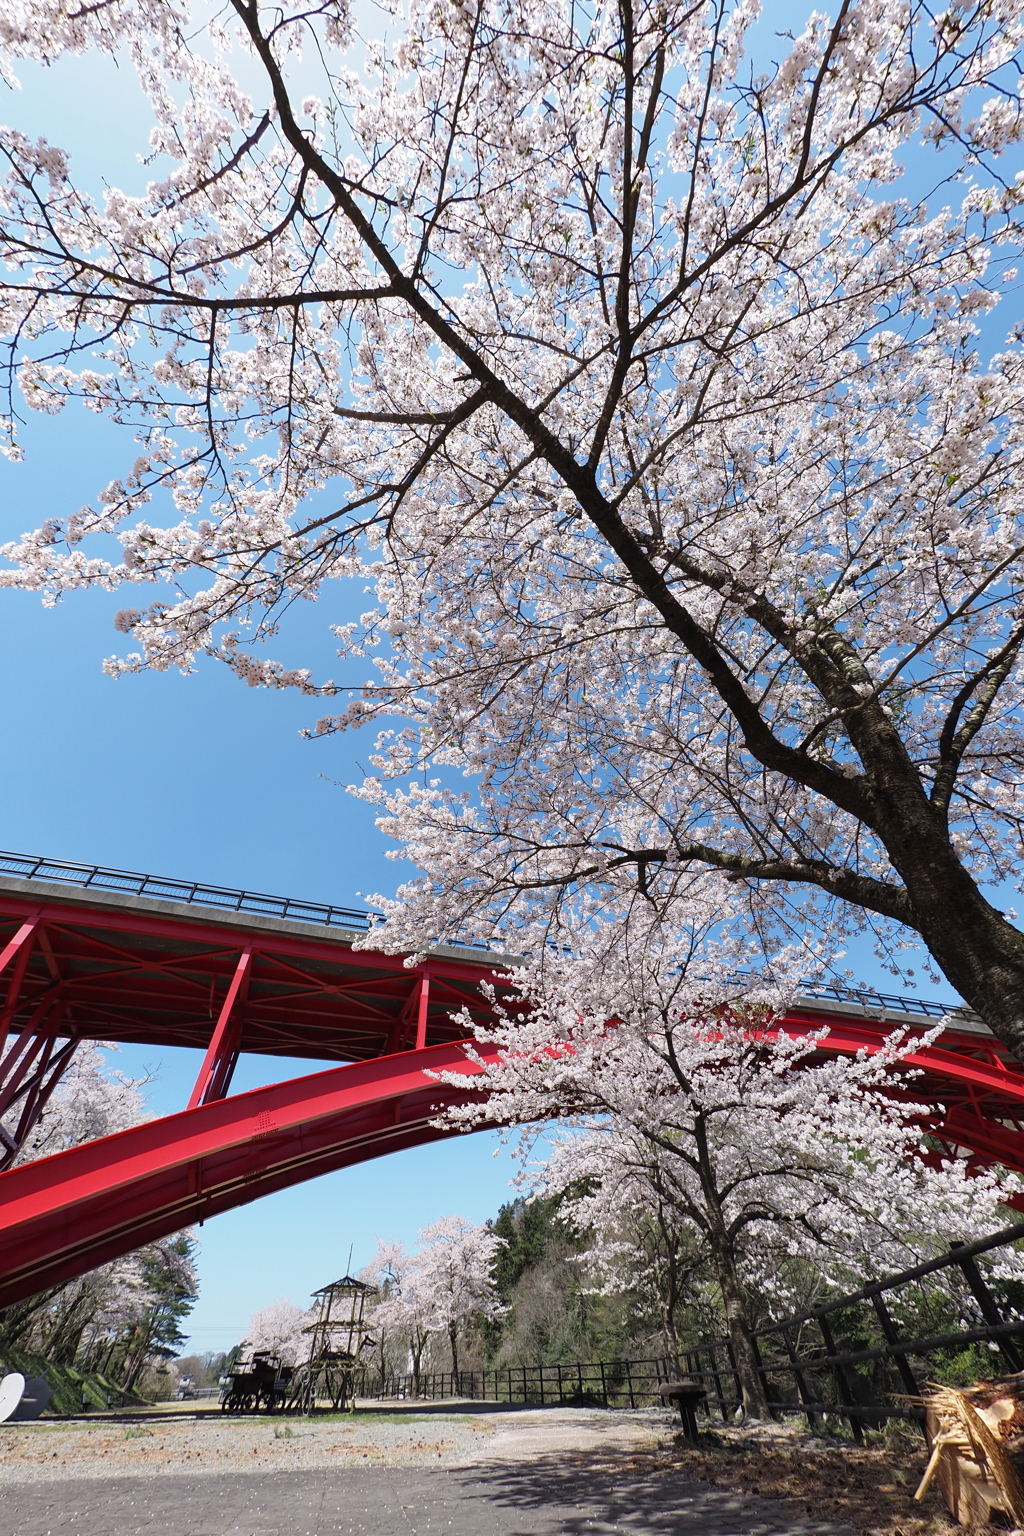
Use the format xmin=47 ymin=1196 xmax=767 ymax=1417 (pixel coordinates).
xmin=368 ymin=1223 xmax=1024 ymax=1439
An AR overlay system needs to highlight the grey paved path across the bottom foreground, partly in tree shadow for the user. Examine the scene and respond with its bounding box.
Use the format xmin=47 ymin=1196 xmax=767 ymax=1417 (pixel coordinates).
xmin=0 ymin=1458 xmax=849 ymax=1536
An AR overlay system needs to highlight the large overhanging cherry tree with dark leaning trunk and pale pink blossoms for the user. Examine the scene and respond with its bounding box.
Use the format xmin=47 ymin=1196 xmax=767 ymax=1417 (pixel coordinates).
xmin=0 ymin=0 xmax=1024 ymax=1058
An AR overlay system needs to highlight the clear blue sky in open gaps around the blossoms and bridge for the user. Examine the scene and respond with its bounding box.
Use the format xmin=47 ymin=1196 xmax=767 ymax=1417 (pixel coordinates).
xmin=0 ymin=18 xmax=994 ymax=1349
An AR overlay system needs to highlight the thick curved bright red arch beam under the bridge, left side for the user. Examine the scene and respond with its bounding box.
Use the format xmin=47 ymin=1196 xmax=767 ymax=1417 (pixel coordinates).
xmin=0 ymin=1044 xmax=500 ymax=1307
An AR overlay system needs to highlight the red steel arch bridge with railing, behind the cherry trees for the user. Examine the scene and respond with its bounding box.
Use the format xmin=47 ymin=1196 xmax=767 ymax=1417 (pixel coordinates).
xmin=0 ymin=854 xmax=1024 ymax=1307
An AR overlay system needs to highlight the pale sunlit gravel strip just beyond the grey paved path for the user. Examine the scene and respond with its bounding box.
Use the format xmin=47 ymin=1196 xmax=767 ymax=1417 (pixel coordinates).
xmin=0 ymin=1402 xmax=671 ymax=1485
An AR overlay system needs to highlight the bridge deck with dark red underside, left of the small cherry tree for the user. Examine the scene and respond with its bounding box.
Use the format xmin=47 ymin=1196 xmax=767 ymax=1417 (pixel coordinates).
xmin=0 ymin=876 xmax=510 ymax=1061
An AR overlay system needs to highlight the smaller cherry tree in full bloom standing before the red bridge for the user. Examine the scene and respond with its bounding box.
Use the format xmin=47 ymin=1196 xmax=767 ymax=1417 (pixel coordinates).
xmin=445 ymin=929 xmax=1024 ymax=1415
